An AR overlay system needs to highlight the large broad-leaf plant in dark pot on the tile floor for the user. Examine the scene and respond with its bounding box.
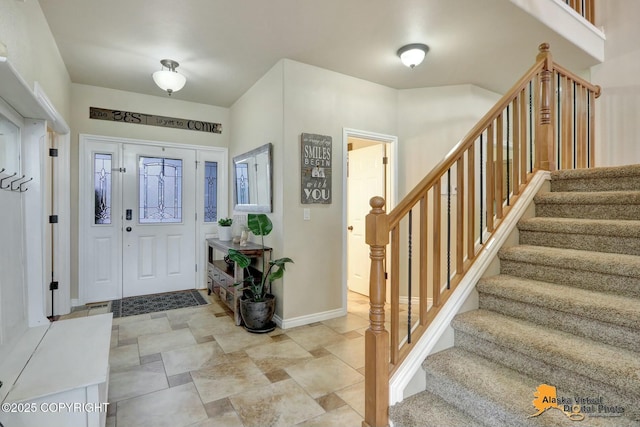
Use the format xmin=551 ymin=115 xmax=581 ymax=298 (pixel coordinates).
xmin=229 ymin=214 xmax=293 ymax=333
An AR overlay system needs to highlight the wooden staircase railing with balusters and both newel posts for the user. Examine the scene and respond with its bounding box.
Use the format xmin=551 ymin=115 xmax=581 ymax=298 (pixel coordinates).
xmin=363 ymin=44 xmax=600 ymax=427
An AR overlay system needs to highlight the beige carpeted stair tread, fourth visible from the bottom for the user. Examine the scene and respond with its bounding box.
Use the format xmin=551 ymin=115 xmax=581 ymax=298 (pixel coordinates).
xmin=477 ymin=274 xmax=640 ymax=332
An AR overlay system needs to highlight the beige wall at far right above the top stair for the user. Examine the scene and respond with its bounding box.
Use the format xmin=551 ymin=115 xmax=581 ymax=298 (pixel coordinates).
xmin=591 ymin=0 xmax=640 ymax=166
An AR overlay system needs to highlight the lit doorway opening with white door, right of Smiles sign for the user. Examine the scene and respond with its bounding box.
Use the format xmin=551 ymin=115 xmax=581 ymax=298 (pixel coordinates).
xmin=343 ymin=129 xmax=398 ymax=318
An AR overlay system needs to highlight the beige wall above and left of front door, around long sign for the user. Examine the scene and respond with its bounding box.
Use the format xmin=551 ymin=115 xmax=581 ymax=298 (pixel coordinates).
xmin=70 ymin=84 xmax=230 ymax=298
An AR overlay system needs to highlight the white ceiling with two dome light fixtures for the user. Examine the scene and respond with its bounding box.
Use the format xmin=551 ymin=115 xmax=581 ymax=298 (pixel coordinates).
xmin=39 ymin=0 xmax=596 ymax=107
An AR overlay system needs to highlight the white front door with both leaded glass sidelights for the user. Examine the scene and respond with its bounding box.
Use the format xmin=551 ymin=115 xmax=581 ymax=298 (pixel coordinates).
xmin=78 ymin=135 xmax=227 ymax=304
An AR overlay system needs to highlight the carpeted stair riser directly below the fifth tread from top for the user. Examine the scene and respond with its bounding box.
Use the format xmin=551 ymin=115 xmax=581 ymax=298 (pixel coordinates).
xmin=480 ymin=292 xmax=640 ymax=352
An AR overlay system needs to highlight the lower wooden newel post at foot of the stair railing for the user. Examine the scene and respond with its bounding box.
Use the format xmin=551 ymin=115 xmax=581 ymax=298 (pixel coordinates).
xmin=362 ymin=197 xmax=389 ymax=427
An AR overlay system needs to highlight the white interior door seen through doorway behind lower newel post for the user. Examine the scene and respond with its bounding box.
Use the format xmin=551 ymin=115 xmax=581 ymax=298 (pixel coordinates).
xmin=347 ymin=143 xmax=385 ymax=296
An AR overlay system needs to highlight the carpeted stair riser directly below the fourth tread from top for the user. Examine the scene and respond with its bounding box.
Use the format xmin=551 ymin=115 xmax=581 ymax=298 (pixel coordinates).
xmin=500 ymin=259 xmax=640 ymax=298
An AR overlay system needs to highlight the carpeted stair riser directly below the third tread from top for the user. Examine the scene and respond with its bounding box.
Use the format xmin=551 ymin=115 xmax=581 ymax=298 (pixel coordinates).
xmin=520 ymin=230 xmax=640 ymax=255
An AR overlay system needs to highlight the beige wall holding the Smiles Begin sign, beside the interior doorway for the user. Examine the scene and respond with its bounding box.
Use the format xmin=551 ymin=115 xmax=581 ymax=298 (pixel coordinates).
xmin=230 ymin=60 xmax=499 ymax=323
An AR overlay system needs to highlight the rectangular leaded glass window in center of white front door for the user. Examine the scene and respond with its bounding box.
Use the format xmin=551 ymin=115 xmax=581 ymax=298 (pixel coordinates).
xmin=138 ymin=157 xmax=182 ymax=224
